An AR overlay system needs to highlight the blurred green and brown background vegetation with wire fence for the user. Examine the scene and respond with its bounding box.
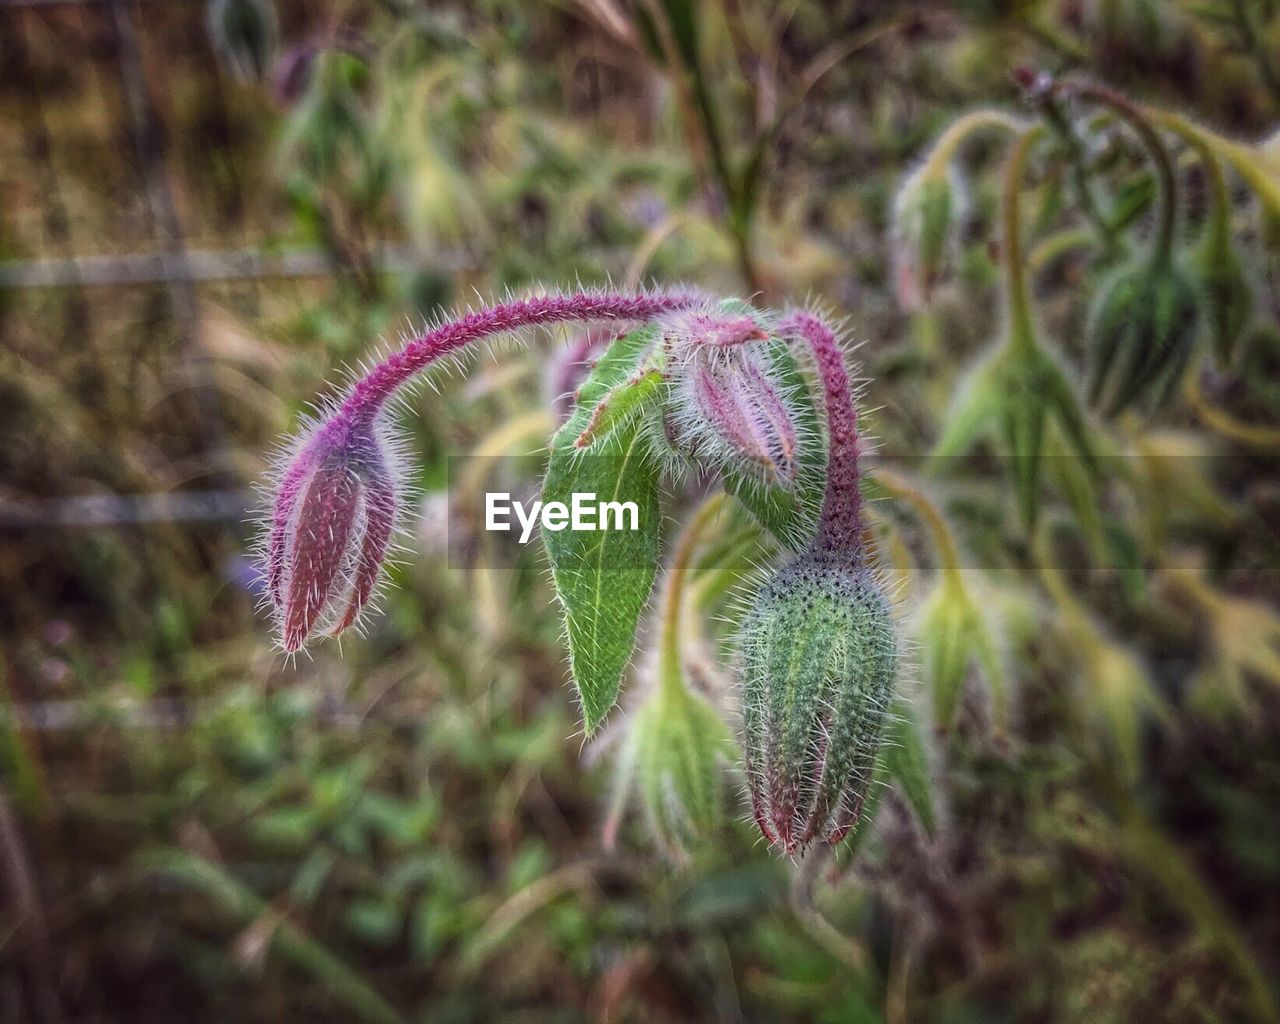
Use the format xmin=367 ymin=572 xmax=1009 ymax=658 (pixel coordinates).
xmin=0 ymin=0 xmax=1280 ymax=1023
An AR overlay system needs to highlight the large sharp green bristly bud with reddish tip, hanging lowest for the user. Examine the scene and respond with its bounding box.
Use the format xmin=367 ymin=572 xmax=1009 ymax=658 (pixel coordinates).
xmin=742 ymin=550 xmax=897 ymax=854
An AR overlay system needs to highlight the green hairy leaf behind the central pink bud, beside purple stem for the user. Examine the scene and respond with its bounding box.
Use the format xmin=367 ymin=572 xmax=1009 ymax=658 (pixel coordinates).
xmin=724 ymin=340 xmax=827 ymax=548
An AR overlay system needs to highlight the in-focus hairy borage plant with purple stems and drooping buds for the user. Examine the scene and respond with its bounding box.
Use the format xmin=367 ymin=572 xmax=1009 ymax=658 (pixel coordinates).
xmin=264 ymin=292 xmax=927 ymax=854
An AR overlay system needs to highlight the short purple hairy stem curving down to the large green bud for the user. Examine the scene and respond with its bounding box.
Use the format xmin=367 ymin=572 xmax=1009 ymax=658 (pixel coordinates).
xmin=781 ymin=312 xmax=863 ymax=558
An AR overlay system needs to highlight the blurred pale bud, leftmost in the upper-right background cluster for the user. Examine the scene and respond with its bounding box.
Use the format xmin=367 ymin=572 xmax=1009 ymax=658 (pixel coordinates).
xmin=893 ymin=165 xmax=957 ymax=310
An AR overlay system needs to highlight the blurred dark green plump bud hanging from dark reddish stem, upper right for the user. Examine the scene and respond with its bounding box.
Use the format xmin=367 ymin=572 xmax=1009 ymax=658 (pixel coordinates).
xmin=1089 ymin=264 xmax=1199 ymax=416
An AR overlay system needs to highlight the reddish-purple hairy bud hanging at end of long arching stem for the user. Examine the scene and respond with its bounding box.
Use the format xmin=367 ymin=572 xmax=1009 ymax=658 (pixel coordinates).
xmin=265 ymin=416 xmax=398 ymax=653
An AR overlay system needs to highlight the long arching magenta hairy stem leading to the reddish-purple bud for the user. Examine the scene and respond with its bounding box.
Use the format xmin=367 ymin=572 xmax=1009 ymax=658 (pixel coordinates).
xmin=335 ymin=292 xmax=699 ymax=421
